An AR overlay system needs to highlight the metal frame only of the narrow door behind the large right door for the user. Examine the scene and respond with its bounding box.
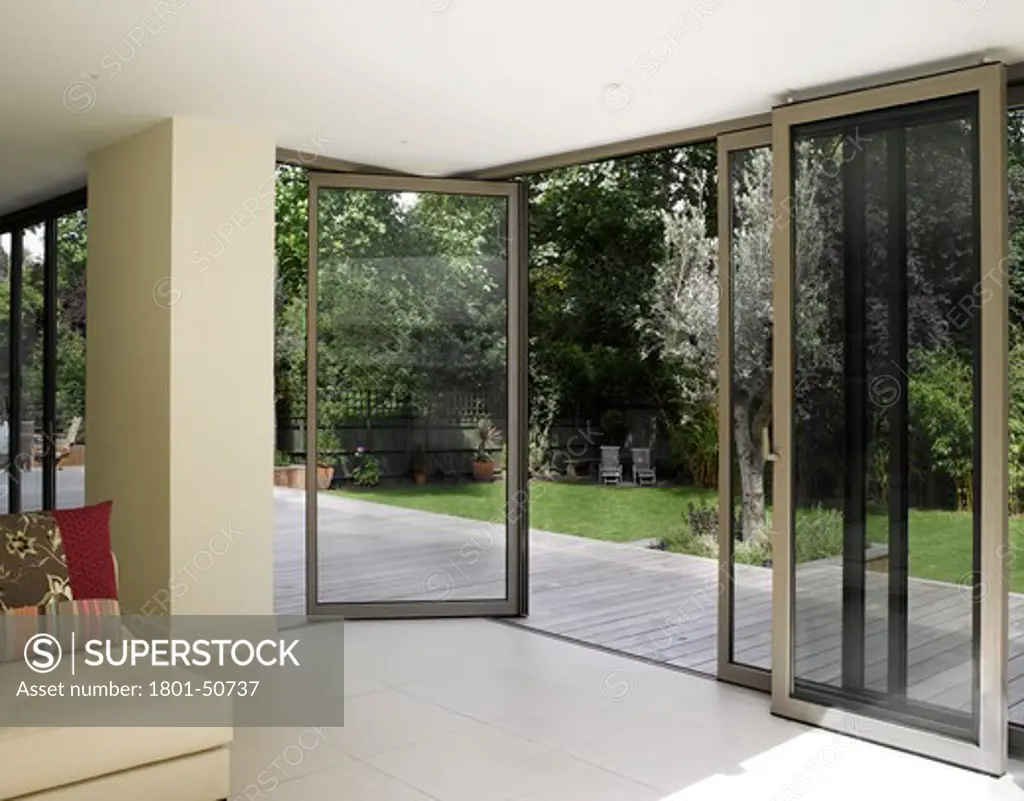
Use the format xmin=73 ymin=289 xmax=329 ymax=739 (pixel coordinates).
xmin=717 ymin=126 xmax=774 ymax=692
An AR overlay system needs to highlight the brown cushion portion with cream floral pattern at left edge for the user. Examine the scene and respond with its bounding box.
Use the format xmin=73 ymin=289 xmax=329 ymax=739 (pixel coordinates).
xmin=0 ymin=512 xmax=72 ymax=612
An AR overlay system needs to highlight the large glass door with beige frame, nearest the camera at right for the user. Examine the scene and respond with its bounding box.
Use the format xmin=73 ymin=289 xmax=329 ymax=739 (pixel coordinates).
xmin=772 ymin=65 xmax=1008 ymax=774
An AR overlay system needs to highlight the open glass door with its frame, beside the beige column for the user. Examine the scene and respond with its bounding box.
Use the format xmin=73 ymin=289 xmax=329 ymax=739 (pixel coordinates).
xmin=306 ymin=173 xmax=528 ymax=618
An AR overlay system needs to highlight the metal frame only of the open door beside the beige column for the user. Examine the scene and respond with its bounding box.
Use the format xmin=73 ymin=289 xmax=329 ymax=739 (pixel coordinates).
xmin=305 ymin=170 xmax=529 ymax=619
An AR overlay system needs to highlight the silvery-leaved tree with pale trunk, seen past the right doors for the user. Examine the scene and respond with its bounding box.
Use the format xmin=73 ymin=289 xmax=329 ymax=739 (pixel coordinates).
xmin=639 ymin=147 xmax=837 ymax=541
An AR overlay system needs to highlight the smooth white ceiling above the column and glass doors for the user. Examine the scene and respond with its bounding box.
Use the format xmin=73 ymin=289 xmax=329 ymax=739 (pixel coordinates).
xmin=0 ymin=0 xmax=1024 ymax=212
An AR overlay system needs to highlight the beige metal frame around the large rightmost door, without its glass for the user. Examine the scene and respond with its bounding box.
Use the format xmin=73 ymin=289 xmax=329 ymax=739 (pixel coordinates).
xmin=771 ymin=64 xmax=1009 ymax=775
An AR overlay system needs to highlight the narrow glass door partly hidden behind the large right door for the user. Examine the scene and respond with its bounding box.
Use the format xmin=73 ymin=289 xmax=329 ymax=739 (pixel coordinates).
xmin=718 ymin=123 xmax=774 ymax=690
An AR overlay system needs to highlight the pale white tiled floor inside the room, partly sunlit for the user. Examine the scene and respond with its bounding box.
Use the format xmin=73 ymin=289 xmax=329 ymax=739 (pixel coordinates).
xmin=232 ymin=620 xmax=1024 ymax=801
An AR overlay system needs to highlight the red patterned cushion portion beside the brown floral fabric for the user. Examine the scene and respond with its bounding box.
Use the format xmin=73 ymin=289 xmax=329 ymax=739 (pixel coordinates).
xmin=52 ymin=501 xmax=118 ymax=600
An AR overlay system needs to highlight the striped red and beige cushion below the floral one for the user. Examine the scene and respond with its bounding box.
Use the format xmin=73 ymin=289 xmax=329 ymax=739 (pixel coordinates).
xmin=0 ymin=598 xmax=122 ymax=662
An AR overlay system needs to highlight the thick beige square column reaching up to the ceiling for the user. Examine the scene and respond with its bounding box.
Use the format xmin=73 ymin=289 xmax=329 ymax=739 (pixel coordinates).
xmin=86 ymin=118 xmax=275 ymax=615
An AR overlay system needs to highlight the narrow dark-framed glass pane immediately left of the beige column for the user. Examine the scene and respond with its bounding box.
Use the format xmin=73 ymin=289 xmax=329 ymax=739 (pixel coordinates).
xmin=55 ymin=211 xmax=86 ymax=508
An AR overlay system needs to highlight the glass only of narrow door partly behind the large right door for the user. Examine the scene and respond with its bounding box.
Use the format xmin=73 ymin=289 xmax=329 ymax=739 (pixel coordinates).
xmin=730 ymin=147 xmax=774 ymax=670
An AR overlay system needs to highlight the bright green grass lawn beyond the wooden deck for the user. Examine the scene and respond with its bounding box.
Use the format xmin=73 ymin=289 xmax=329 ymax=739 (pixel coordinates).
xmin=338 ymin=481 xmax=1024 ymax=592
